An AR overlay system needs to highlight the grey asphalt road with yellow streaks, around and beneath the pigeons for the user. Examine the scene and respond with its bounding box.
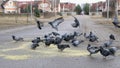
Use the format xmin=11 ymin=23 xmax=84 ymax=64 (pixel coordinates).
xmin=0 ymin=16 xmax=120 ymax=68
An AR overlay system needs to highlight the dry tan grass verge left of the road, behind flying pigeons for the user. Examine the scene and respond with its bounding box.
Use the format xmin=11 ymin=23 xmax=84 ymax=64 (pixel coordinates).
xmin=0 ymin=15 xmax=68 ymax=30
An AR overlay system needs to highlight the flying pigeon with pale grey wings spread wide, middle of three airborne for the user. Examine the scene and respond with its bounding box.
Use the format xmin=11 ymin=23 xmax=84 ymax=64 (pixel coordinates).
xmin=49 ymin=17 xmax=64 ymax=31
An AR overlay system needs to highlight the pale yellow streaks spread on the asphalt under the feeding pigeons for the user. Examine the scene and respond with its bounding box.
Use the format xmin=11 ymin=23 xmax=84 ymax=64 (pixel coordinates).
xmin=0 ymin=42 xmax=89 ymax=60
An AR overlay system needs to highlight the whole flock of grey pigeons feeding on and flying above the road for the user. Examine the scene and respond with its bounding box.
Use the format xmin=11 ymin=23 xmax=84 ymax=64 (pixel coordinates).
xmin=12 ymin=16 xmax=117 ymax=58
